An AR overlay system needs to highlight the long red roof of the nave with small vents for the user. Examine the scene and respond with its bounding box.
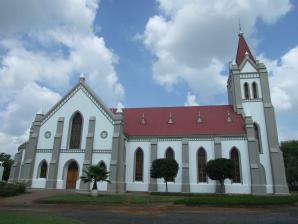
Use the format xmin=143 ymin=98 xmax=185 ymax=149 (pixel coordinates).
xmin=113 ymin=105 xmax=245 ymax=136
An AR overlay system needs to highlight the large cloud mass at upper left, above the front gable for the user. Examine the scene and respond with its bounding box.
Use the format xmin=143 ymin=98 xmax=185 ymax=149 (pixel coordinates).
xmin=0 ymin=0 xmax=124 ymax=154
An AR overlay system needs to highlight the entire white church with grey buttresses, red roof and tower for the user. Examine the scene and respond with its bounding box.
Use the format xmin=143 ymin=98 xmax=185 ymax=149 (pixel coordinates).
xmin=10 ymin=33 xmax=289 ymax=194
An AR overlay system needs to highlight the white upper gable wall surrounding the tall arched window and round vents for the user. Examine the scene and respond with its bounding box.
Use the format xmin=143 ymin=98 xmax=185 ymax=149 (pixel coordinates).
xmin=37 ymin=79 xmax=114 ymax=149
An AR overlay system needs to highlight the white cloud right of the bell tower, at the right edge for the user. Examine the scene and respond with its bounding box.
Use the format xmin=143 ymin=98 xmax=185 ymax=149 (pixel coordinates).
xmin=259 ymin=46 xmax=298 ymax=140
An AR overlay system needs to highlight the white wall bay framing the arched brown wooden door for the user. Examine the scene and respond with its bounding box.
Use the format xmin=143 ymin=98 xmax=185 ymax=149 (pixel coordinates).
xmin=57 ymin=152 xmax=85 ymax=190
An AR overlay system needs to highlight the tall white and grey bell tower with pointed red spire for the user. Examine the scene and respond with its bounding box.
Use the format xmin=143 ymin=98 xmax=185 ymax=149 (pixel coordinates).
xmin=227 ymin=32 xmax=289 ymax=194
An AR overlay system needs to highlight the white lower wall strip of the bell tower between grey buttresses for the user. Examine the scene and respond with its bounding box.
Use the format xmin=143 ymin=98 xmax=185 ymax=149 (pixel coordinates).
xmin=243 ymin=102 xmax=273 ymax=193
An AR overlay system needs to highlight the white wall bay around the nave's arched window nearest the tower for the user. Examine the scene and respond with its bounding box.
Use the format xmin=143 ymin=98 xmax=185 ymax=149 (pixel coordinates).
xmin=221 ymin=140 xmax=251 ymax=194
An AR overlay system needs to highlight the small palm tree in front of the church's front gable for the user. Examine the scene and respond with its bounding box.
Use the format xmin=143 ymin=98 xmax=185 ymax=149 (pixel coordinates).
xmin=81 ymin=165 xmax=110 ymax=190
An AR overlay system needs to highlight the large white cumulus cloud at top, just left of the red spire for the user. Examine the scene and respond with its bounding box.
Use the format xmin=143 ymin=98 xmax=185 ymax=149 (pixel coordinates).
xmin=143 ymin=0 xmax=291 ymax=102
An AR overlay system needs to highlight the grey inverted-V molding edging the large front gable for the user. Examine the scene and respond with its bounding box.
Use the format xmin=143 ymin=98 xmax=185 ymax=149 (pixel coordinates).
xmin=41 ymin=81 xmax=114 ymax=125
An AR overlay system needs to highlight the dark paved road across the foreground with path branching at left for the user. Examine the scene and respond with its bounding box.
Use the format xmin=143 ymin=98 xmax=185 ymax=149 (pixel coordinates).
xmin=0 ymin=190 xmax=298 ymax=224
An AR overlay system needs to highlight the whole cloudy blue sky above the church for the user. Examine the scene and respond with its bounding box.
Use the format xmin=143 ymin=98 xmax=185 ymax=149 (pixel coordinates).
xmin=0 ymin=0 xmax=298 ymax=153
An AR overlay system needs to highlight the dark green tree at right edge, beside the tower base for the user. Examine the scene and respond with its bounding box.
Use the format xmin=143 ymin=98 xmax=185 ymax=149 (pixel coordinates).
xmin=280 ymin=140 xmax=298 ymax=190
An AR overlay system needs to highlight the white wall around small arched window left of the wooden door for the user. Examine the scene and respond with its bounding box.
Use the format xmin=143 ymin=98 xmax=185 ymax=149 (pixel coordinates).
xmin=32 ymin=153 xmax=52 ymax=188
